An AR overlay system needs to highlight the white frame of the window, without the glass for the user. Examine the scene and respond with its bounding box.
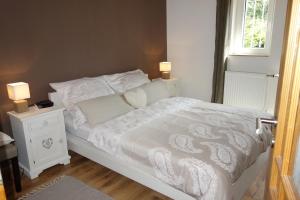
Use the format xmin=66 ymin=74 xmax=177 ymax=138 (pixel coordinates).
xmin=229 ymin=0 xmax=276 ymax=56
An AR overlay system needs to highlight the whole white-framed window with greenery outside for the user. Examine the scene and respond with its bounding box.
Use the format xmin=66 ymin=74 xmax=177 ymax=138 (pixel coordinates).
xmin=230 ymin=0 xmax=275 ymax=56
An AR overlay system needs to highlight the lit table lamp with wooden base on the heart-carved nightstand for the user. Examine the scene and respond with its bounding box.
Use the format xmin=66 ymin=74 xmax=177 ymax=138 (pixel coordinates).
xmin=7 ymin=82 xmax=30 ymax=113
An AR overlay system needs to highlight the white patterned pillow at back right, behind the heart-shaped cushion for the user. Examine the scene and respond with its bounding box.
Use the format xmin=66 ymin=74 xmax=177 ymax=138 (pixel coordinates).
xmin=104 ymin=69 xmax=150 ymax=93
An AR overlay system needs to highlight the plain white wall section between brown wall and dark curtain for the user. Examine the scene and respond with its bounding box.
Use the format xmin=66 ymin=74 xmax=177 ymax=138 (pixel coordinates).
xmin=167 ymin=0 xmax=216 ymax=101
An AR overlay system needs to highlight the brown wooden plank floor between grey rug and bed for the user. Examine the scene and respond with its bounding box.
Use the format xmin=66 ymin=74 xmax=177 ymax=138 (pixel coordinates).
xmin=7 ymin=152 xmax=259 ymax=200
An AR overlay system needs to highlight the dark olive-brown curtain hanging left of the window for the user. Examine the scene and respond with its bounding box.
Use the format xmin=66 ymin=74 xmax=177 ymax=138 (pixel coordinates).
xmin=211 ymin=0 xmax=231 ymax=103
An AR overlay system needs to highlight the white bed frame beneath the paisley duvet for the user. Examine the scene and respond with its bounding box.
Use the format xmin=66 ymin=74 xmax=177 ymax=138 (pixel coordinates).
xmin=49 ymin=93 xmax=270 ymax=200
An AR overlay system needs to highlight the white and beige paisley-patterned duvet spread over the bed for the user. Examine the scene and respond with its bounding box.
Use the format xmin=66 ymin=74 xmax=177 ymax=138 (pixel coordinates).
xmin=88 ymin=97 xmax=271 ymax=200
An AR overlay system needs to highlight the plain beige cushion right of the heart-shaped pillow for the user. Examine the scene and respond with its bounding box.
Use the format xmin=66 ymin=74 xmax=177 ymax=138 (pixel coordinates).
xmin=142 ymin=80 xmax=170 ymax=105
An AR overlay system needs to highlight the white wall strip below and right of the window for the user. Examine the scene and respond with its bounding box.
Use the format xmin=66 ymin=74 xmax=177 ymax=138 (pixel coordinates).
xmin=228 ymin=0 xmax=287 ymax=74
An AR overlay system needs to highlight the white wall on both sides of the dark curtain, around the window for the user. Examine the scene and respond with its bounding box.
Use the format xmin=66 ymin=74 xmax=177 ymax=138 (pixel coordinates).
xmin=167 ymin=0 xmax=287 ymax=101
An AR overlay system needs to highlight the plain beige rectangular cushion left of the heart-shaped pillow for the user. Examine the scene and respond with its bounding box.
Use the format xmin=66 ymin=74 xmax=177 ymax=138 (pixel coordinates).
xmin=77 ymin=95 xmax=133 ymax=127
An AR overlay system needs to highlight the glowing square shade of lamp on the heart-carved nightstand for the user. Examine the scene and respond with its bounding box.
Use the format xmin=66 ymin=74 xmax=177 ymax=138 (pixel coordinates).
xmin=7 ymin=82 xmax=30 ymax=101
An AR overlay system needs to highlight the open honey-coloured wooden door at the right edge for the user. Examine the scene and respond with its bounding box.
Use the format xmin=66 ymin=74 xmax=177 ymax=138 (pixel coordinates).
xmin=266 ymin=0 xmax=300 ymax=200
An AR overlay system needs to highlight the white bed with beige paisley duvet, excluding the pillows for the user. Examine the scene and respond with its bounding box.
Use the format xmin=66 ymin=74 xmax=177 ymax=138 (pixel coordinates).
xmin=49 ymin=70 xmax=271 ymax=200
